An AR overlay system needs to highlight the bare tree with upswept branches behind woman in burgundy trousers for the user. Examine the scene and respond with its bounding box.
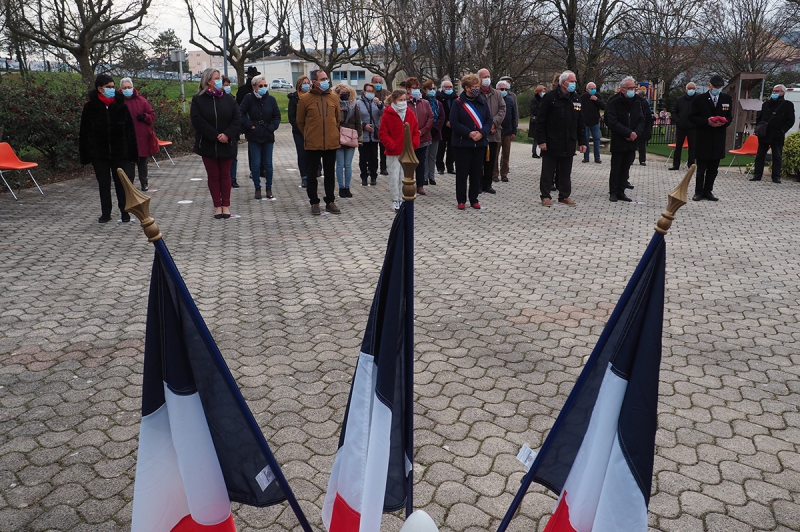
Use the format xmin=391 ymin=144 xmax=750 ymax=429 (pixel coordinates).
xmin=184 ymin=0 xmax=288 ymax=83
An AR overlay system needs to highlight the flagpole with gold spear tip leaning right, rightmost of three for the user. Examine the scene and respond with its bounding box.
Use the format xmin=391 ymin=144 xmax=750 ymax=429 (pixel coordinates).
xmin=497 ymin=165 xmax=696 ymax=532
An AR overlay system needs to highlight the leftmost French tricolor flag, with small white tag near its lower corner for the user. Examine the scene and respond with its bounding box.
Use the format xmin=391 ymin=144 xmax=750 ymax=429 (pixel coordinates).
xmin=132 ymin=240 xmax=310 ymax=532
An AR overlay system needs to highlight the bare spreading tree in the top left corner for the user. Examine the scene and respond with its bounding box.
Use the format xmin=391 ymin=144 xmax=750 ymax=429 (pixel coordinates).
xmin=6 ymin=0 xmax=151 ymax=87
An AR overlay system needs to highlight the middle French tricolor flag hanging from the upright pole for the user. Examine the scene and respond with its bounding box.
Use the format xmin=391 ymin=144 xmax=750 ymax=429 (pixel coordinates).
xmin=322 ymin=202 xmax=413 ymax=532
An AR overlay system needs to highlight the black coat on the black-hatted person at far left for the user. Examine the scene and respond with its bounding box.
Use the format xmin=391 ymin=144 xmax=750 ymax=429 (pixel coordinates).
xmin=78 ymin=89 xmax=139 ymax=164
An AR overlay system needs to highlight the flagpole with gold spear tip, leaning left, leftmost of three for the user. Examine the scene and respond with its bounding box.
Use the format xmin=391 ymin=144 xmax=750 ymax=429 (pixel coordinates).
xmin=117 ymin=168 xmax=312 ymax=532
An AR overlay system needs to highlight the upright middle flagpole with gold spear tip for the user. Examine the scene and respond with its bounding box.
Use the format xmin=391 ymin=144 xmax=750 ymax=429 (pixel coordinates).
xmin=400 ymin=124 xmax=419 ymax=519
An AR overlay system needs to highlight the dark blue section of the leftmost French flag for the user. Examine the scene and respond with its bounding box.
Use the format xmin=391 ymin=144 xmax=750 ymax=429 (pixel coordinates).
xmin=142 ymin=240 xmax=290 ymax=508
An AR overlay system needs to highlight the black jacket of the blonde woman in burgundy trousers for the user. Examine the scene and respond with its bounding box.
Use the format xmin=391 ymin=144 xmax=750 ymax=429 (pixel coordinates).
xmin=190 ymin=91 xmax=241 ymax=159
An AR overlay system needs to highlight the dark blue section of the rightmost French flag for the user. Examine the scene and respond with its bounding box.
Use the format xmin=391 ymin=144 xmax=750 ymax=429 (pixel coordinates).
xmin=529 ymin=233 xmax=666 ymax=503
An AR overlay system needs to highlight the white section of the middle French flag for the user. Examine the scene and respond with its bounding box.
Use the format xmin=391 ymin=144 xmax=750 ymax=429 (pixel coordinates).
xmin=322 ymin=353 xmax=392 ymax=532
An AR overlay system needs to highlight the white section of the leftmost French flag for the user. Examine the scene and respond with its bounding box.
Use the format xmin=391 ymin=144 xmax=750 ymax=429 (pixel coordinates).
xmin=131 ymin=384 xmax=231 ymax=532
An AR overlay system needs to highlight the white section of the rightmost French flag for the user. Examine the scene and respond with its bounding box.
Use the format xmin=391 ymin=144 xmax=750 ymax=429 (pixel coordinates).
xmin=562 ymin=365 xmax=647 ymax=532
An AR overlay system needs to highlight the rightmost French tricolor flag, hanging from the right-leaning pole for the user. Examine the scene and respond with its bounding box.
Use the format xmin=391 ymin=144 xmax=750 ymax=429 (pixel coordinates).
xmin=498 ymin=233 xmax=666 ymax=532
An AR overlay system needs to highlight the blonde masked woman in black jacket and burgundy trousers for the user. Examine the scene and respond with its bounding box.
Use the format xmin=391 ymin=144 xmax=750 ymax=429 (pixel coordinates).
xmin=190 ymin=68 xmax=239 ymax=219
